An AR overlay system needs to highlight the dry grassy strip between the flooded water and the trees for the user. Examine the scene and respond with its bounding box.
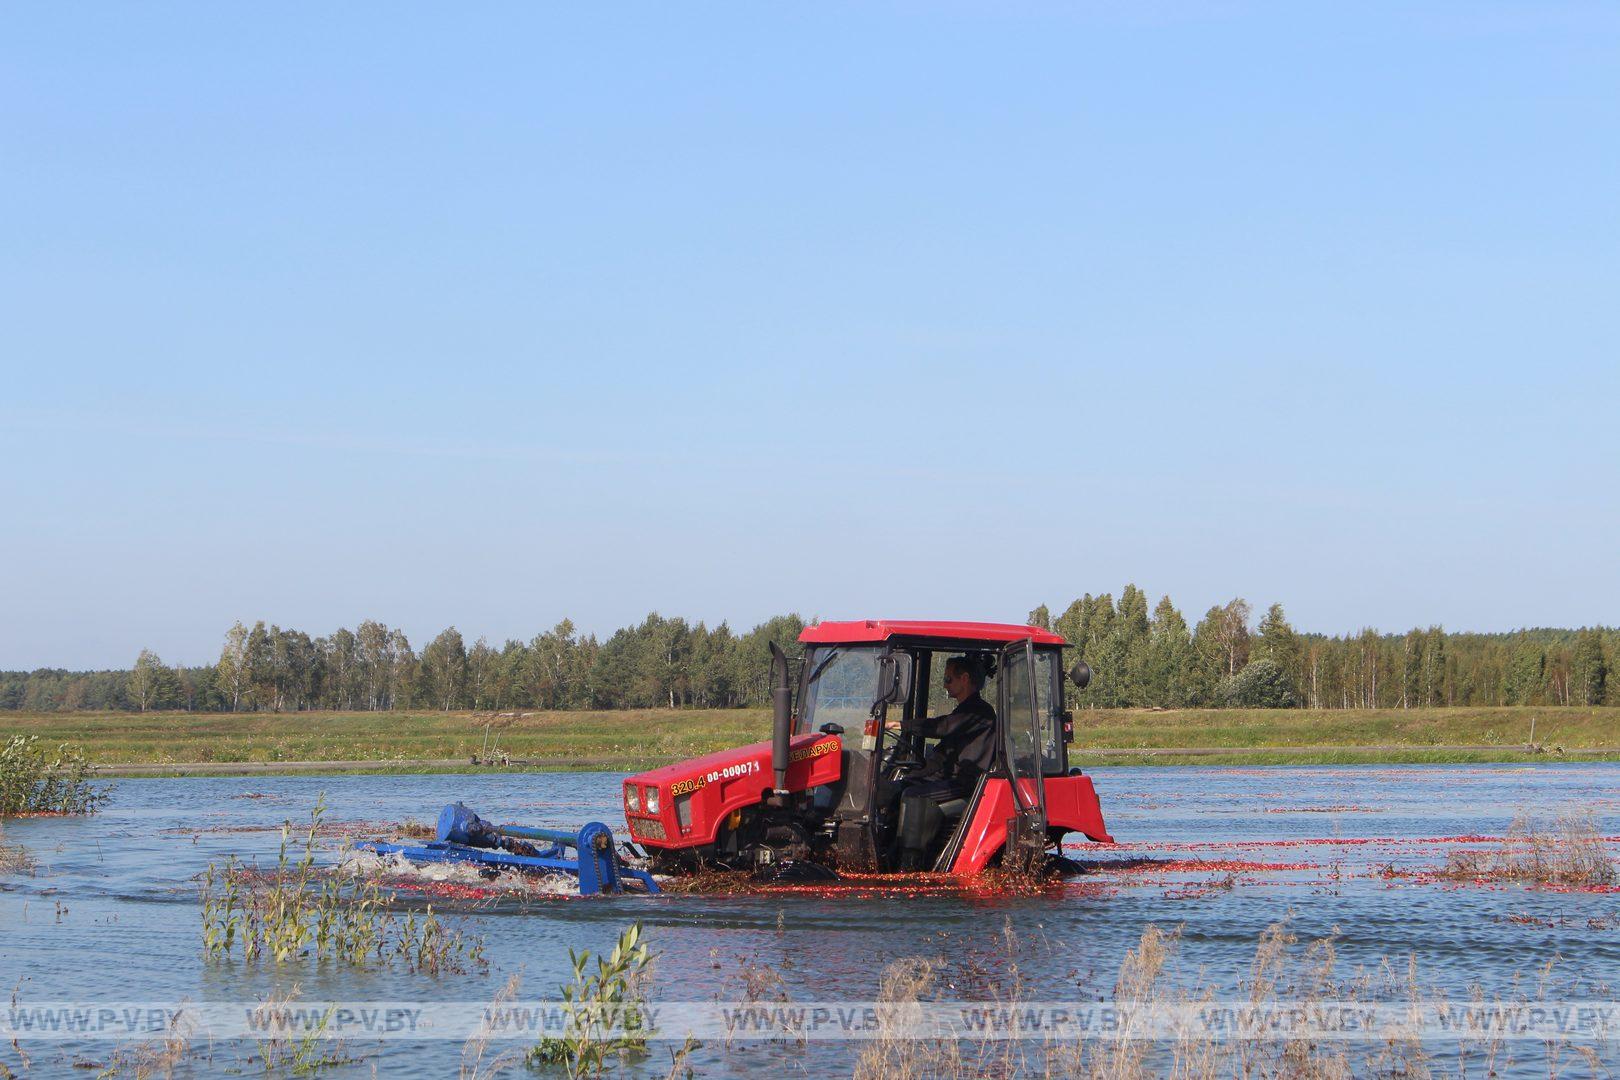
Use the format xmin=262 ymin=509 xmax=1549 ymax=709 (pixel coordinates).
xmin=9 ymin=706 xmax=1620 ymax=777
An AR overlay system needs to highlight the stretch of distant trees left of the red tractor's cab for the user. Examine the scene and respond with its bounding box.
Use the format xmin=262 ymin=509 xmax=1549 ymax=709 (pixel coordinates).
xmin=0 ymin=614 xmax=805 ymax=712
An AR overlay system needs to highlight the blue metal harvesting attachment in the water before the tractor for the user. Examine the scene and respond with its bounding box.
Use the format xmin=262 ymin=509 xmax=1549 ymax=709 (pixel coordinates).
xmin=355 ymin=803 xmax=658 ymax=895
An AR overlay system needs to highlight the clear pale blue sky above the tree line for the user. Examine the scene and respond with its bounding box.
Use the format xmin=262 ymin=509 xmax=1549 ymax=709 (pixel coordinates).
xmin=0 ymin=2 xmax=1620 ymax=669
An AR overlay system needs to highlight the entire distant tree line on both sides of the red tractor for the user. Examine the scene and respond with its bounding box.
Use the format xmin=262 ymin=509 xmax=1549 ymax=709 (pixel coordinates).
xmin=0 ymin=585 xmax=1620 ymax=712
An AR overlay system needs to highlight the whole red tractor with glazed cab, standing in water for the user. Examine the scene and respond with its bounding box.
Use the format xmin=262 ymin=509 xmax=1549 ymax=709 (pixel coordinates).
xmin=624 ymin=620 xmax=1113 ymax=878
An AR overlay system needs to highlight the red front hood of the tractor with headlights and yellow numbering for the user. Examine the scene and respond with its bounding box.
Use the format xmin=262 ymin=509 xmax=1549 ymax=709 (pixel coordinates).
xmin=624 ymin=735 xmax=844 ymax=847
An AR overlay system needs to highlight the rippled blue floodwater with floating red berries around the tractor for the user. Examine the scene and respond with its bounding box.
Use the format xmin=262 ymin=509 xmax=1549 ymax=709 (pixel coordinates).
xmin=0 ymin=764 xmax=1620 ymax=1077
